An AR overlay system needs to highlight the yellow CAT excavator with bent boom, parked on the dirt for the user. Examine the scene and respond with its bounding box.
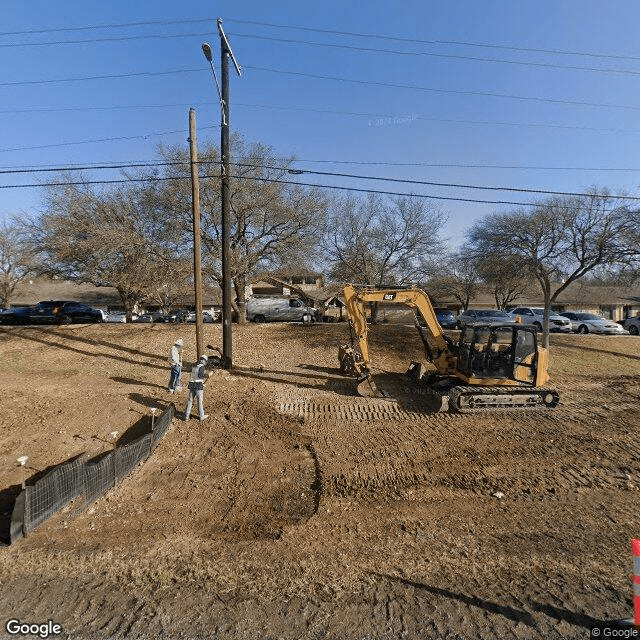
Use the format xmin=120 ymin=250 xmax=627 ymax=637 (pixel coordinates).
xmin=338 ymin=284 xmax=559 ymax=413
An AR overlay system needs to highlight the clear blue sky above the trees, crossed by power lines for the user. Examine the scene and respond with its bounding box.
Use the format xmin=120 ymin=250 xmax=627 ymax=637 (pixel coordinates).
xmin=0 ymin=0 xmax=640 ymax=244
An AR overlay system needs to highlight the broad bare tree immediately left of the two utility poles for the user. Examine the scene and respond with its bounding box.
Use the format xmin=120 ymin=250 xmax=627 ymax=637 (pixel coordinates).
xmin=30 ymin=176 xmax=185 ymax=320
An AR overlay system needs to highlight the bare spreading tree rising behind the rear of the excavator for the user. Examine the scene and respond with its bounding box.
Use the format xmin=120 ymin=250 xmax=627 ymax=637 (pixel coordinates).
xmin=467 ymin=190 xmax=638 ymax=347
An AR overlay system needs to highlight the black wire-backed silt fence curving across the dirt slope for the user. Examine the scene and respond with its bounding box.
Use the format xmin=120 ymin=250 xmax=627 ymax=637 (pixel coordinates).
xmin=10 ymin=405 xmax=175 ymax=543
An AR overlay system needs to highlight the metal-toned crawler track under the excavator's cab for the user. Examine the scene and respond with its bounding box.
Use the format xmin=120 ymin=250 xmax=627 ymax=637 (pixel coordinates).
xmin=448 ymin=386 xmax=560 ymax=413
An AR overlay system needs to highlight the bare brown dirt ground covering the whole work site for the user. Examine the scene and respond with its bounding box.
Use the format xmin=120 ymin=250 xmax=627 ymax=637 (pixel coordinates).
xmin=0 ymin=324 xmax=640 ymax=640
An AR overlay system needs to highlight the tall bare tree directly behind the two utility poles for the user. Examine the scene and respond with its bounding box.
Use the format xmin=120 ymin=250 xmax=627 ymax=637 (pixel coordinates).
xmin=146 ymin=136 xmax=327 ymax=321
